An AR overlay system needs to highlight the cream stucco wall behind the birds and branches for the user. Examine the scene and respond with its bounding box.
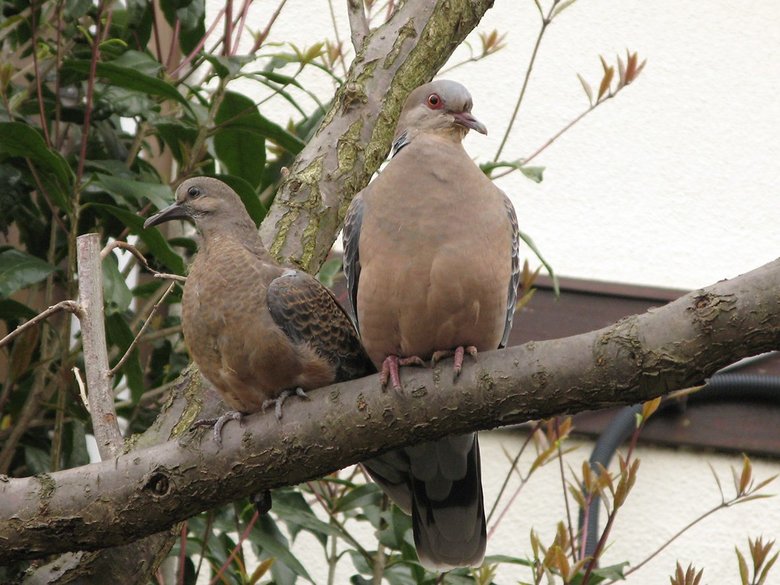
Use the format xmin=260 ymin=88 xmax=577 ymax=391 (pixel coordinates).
xmin=201 ymin=0 xmax=780 ymax=585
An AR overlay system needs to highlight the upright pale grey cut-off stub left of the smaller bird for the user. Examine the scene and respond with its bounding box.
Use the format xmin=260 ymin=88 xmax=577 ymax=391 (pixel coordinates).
xmin=77 ymin=234 xmax=124 ymax=460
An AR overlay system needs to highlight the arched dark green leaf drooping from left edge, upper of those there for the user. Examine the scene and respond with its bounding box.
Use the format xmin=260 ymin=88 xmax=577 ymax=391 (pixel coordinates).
xmin=0 ymin=122 xmax=75 ymax=210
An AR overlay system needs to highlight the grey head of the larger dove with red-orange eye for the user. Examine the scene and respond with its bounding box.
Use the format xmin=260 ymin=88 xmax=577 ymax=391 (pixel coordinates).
xmin=396 ymin=79 xmax=487 ymax=145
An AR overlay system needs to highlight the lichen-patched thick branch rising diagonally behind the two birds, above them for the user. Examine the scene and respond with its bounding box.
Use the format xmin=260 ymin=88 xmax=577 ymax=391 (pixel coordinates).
xmin=260 ymin=0 xmax=493 ymax=273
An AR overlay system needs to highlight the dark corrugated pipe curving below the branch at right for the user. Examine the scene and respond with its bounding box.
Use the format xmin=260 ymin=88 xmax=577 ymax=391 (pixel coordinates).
xmin=579 ymin=354 xmax=780 ymax=556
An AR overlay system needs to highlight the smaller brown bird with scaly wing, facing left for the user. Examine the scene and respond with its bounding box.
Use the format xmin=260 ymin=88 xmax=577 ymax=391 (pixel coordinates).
xmin=144 ymin=177 xmax=375 ymax=441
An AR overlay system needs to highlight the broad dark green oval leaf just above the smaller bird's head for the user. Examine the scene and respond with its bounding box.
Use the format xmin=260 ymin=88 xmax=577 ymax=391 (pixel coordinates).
xmin=214 ymin=91 xmax=265 ymax=189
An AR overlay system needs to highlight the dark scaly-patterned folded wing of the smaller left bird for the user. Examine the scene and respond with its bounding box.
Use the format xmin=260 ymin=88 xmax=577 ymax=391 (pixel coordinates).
xmin=267 ymin=270 xmax=375 ymax=382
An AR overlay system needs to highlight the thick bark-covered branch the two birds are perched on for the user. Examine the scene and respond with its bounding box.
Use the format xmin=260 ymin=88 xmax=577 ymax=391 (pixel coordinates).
xmin=0 ymin=260 xmax=780 ymax=563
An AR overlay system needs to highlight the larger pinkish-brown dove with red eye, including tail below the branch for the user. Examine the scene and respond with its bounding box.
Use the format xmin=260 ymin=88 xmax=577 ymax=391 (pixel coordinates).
xmin=344 ymin=81 xmax=519 ymax=569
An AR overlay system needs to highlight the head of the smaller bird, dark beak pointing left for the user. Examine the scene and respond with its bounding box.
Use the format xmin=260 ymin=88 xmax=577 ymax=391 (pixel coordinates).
xmin=144 ymin=177 xmax=255 ymax=235
